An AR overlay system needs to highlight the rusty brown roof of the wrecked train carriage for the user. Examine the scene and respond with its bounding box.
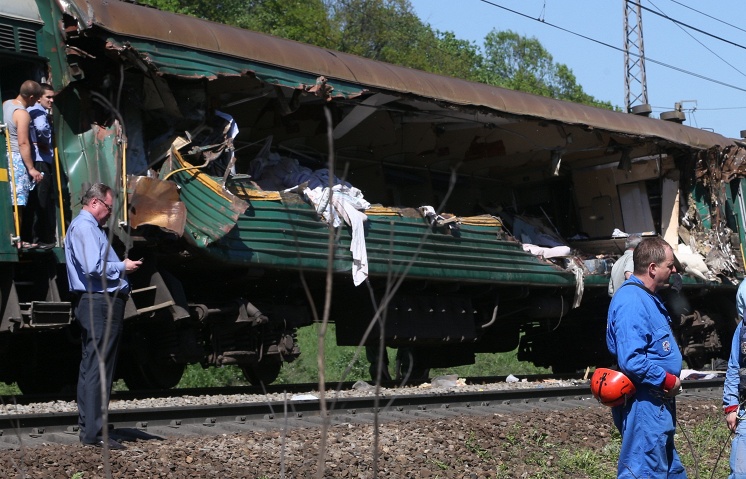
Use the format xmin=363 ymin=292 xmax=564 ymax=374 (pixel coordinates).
xmin=57 ymin=0 xmax=732 ymax=152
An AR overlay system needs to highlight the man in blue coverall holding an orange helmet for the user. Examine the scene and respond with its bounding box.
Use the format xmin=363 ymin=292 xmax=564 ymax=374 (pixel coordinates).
xmin=606 ymin=237 xmax=687 ymax=479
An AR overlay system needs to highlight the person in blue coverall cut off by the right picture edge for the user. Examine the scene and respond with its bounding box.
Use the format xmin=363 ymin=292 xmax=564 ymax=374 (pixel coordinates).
xmin=723 ymin=281 xmax=746 ymax=479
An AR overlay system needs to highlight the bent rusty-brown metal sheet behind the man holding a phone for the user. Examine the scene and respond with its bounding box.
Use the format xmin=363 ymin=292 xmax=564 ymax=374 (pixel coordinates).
xmin=127 ymin=176 xmax=187 ymax=236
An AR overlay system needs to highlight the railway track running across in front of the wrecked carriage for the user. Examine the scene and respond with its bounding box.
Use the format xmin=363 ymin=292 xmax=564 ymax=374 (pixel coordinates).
xmin=0 ymin=378 xmax=723 ymax=449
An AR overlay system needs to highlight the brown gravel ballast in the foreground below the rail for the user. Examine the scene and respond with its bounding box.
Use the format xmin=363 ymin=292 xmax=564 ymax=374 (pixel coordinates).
xmin=0 ymin=400 xmax=727 ymax=479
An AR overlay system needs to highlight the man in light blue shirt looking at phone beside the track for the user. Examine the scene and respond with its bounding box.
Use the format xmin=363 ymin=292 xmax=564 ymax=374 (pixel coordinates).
xmin=65 ymin=183 xmax=142 ymax=449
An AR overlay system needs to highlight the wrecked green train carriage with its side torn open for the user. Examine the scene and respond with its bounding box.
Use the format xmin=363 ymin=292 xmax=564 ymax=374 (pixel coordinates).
xmin=0 ymin=0 xmax=744 ymax=392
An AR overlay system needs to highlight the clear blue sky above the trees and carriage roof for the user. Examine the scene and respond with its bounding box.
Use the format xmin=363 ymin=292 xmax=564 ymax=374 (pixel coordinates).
xmin=410 ymin=0 xmax=746 ymax=138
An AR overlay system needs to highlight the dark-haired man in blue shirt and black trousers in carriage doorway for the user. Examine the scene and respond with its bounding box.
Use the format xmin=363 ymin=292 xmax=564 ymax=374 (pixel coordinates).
xmin=23 ymin=83 xmax=57 ymax=249
